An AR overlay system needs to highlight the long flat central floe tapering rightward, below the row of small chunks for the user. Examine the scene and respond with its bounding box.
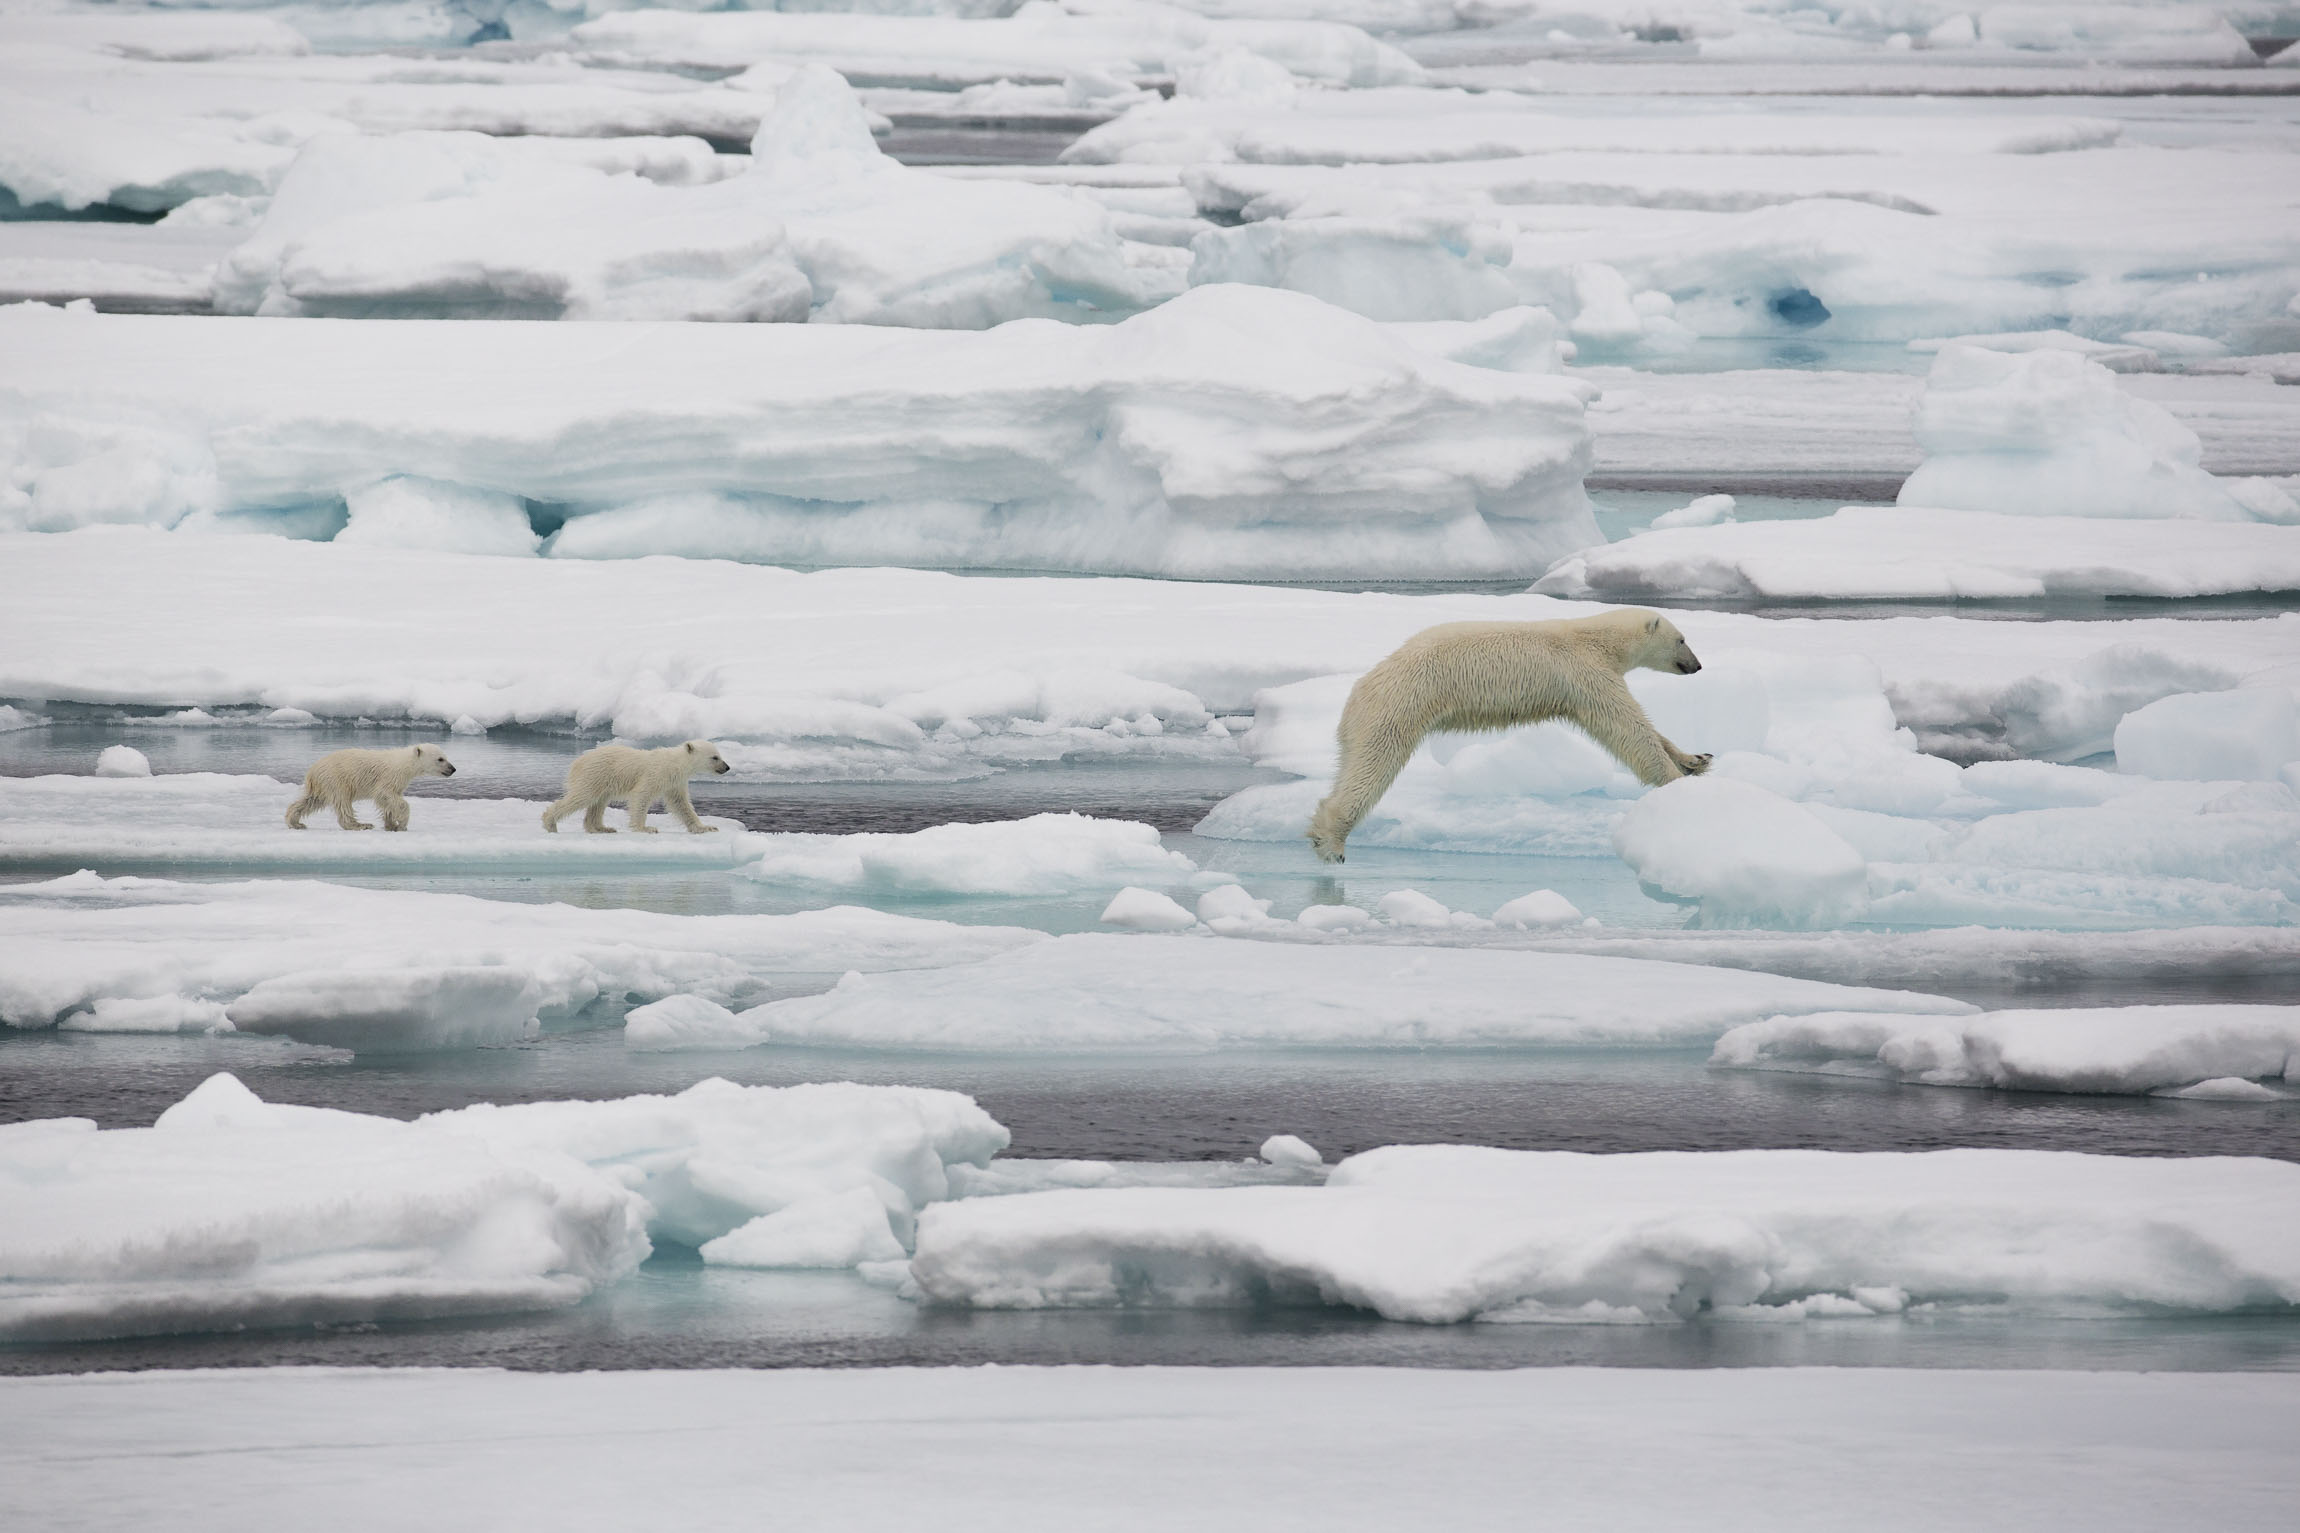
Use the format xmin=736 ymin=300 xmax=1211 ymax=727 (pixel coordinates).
xmin=743 ymin=933 xmax=1971 ymax=1053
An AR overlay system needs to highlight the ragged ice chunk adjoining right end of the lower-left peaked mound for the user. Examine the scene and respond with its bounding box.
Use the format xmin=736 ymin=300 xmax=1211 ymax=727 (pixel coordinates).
xmin=432 ymin=1078 xmax=1007 ymax=1259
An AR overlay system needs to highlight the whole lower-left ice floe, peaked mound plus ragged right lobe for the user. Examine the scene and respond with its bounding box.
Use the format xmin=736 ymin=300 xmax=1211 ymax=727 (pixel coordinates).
xmin=0 ymin=1076 xmax=1007 ymax=1340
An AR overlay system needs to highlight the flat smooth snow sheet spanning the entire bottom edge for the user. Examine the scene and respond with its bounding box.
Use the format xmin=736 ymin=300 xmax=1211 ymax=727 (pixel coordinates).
xmin=0 ymin=1368 xmax=2300 ymax=1533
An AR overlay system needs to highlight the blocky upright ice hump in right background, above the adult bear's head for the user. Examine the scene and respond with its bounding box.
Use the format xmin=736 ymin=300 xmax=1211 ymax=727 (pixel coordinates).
xmin=1900 ymin=345 xmax=2249 ymax=522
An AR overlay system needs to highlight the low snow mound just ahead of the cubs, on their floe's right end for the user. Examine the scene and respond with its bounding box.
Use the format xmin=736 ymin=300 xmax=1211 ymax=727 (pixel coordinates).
xmin=743 ymin=814 xmax=1198 ymax=896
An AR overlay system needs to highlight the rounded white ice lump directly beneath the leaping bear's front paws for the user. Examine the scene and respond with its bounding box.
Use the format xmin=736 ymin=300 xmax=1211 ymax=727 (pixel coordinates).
xmin=1612 ymin=777 xmax=1868 ymax=926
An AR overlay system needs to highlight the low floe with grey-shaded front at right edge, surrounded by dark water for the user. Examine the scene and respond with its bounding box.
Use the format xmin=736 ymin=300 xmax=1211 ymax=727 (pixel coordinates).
xmin=1709 ymin=1004 xmax=2300 ymax=1101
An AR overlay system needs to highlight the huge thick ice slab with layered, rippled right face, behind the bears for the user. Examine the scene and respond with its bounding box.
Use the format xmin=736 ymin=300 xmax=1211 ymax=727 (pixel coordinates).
xmin=0 ymin=287 xmax=1599 ymax=579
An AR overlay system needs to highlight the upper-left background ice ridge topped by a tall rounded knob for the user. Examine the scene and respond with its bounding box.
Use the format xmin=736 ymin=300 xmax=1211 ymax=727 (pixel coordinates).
xmin=216 ymin=67 xmax=1182 ymax=329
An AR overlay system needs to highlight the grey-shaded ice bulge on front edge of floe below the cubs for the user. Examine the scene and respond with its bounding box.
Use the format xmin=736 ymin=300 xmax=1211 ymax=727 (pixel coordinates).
xmin=225 ymin=965 xmax=543 ymax=1055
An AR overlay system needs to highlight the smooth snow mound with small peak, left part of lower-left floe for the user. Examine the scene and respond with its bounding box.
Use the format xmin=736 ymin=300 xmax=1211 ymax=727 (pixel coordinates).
xmin=0 ymin=1076 xmax=649 ymax=1340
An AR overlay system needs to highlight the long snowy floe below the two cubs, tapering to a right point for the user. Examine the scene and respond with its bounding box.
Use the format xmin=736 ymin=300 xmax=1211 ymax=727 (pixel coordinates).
xmin=0 ymin=873 xmax=1042 ymax=1048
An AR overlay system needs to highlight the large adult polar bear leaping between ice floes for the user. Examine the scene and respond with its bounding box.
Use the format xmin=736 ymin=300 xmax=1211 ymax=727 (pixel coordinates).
xmin=1309 ymin=607 xmax=1709 ymax=862
